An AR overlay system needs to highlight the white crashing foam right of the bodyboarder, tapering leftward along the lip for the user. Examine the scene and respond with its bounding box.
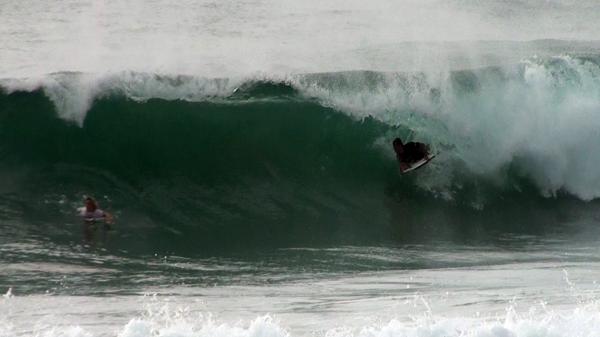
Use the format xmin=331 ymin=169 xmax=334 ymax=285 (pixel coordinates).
xmin=298 ymin=56 xmax=600 ymax=200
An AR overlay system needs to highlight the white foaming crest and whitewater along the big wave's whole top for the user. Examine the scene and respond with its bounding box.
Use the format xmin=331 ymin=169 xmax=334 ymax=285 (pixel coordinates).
xmin=1 ymin=56 xmax=600 ymax=200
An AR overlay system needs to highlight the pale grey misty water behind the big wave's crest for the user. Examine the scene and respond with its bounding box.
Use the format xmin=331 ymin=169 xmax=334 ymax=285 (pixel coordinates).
xmin=0 ymin=0 xmax=600 ymax=77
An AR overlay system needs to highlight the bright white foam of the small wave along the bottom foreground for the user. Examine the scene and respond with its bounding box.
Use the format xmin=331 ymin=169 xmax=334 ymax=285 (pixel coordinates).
xmin=0 ymin=304 xmax=600 ymax=337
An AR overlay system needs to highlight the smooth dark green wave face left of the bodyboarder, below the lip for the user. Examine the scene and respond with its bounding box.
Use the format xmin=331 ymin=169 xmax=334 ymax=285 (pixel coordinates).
xmin=0 ymin=88 xmax=408 ymax=251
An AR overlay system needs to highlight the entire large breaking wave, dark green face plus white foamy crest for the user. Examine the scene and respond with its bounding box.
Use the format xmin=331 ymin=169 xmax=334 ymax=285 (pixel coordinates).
xmin=0 ymin=56 xmax=600 ymax=245
